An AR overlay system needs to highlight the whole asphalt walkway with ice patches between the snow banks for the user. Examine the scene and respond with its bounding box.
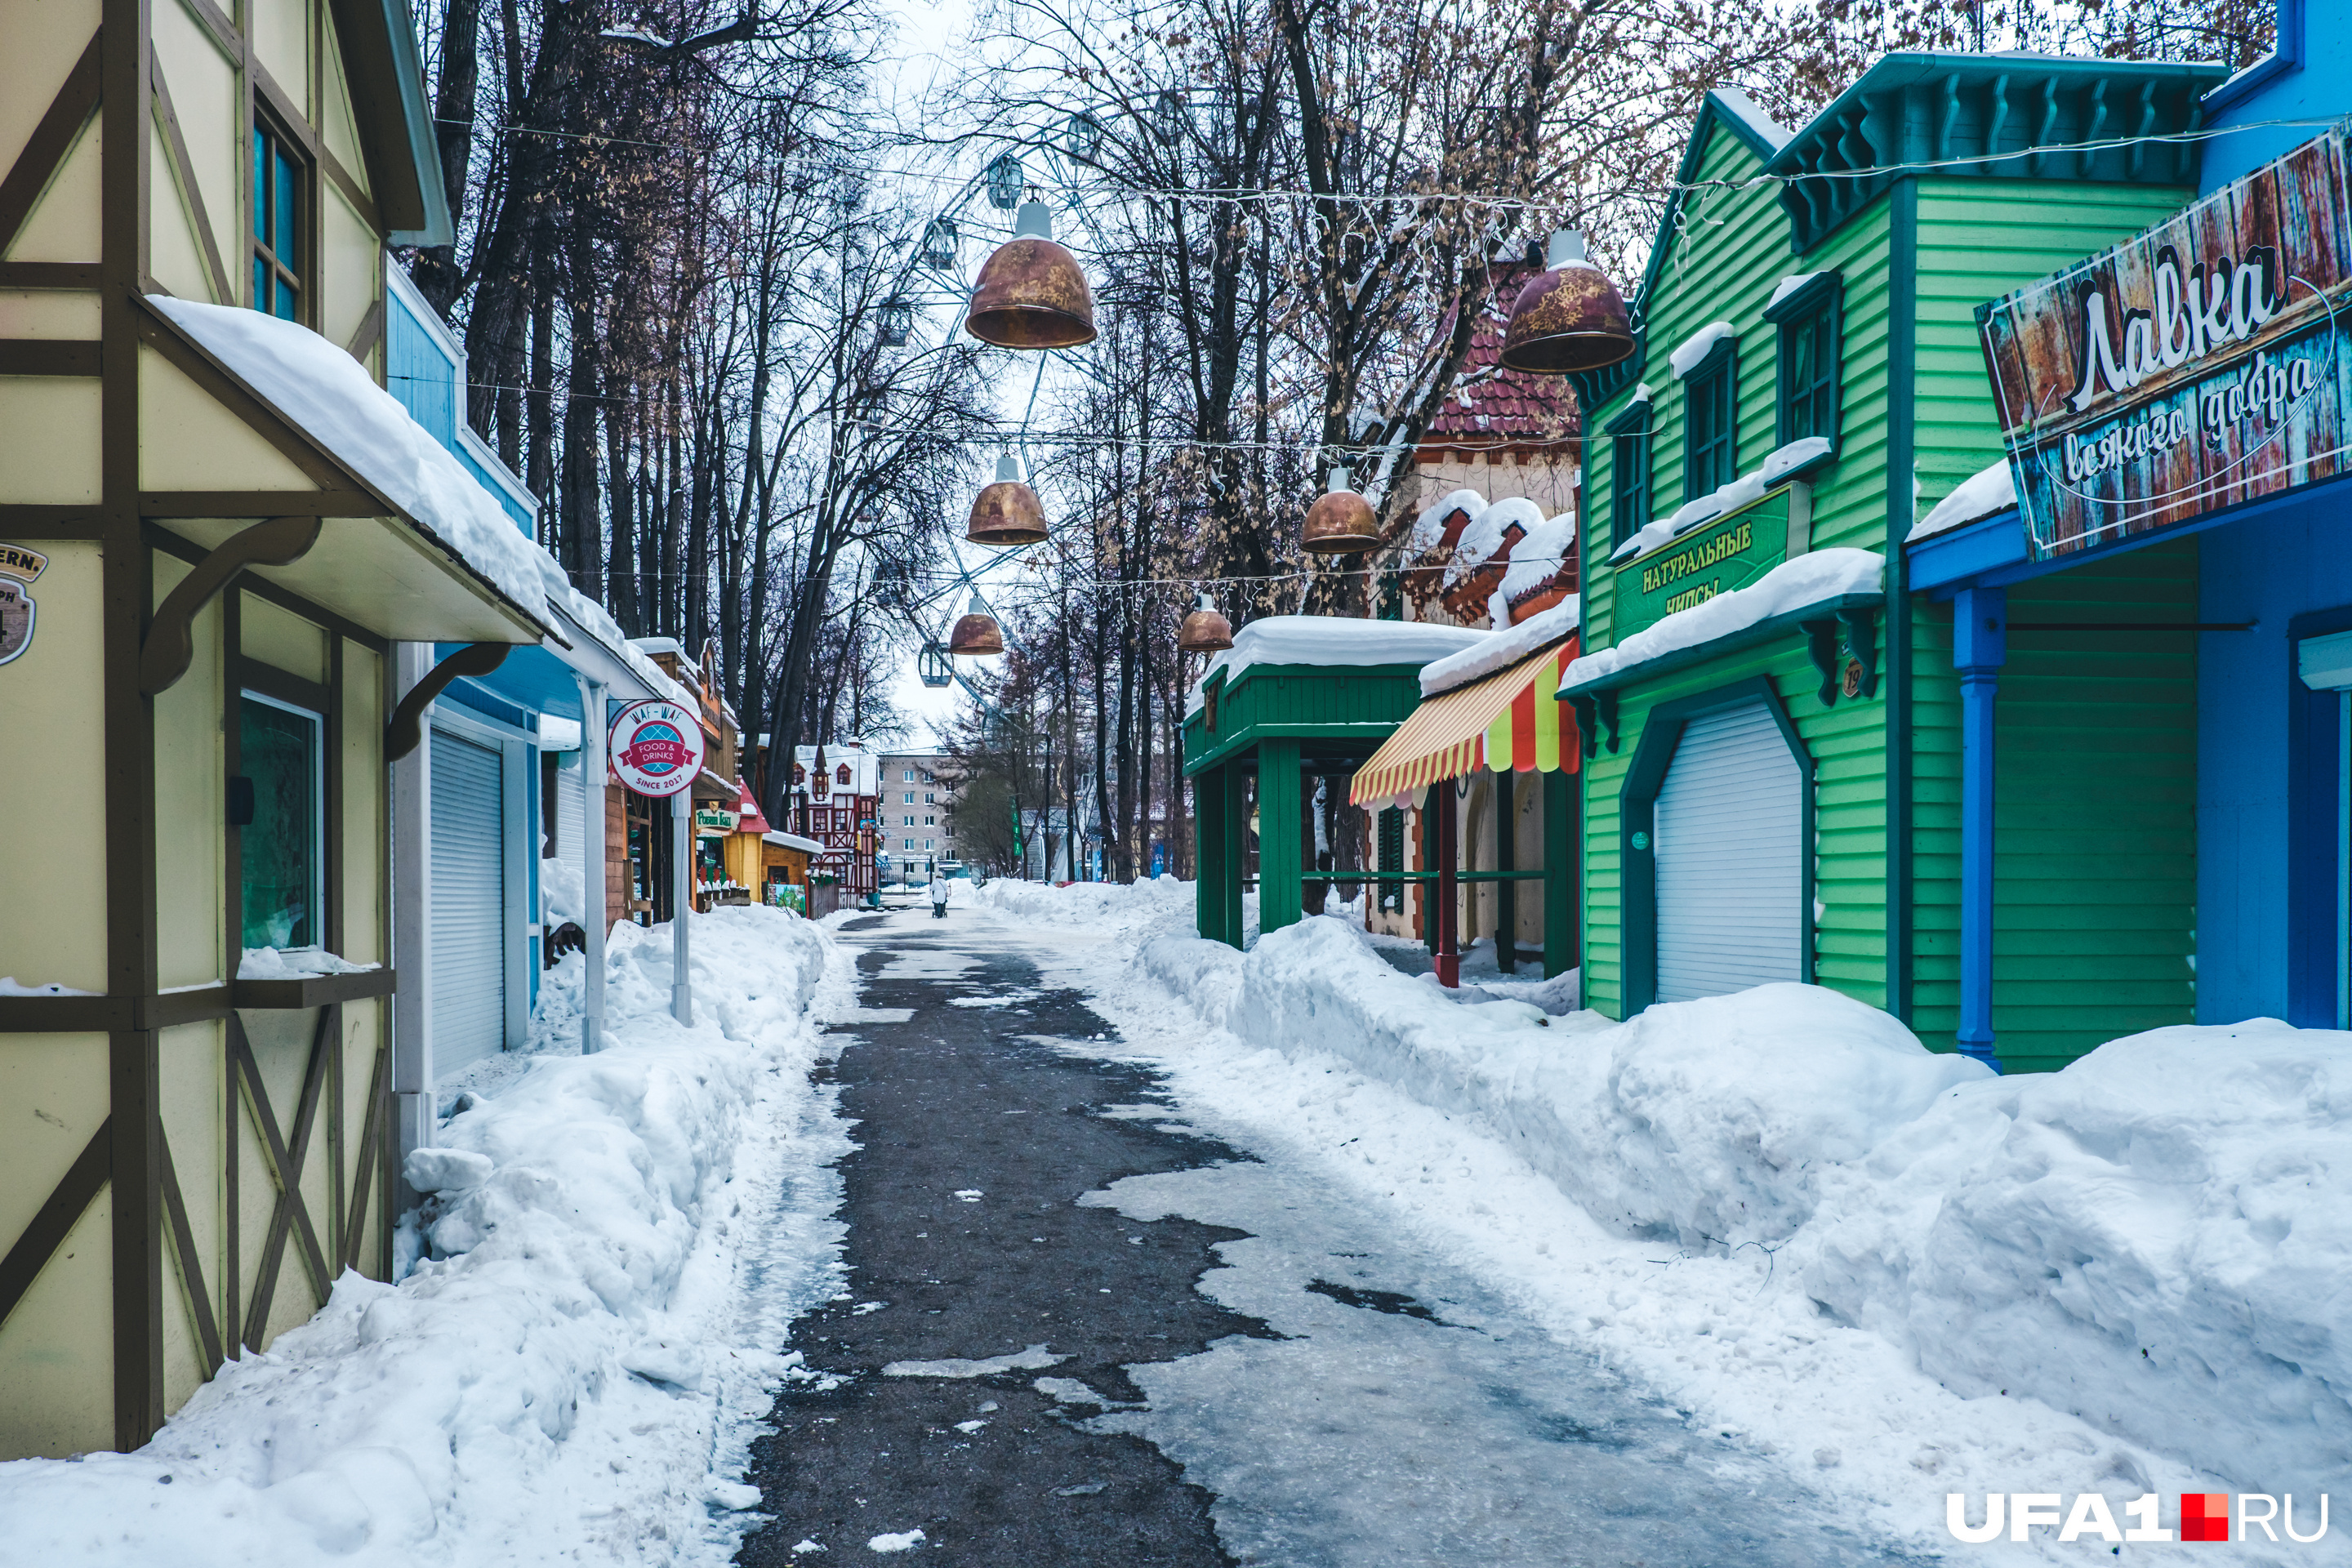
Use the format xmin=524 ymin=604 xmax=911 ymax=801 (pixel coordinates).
xmin=741 ymin=915 xmax=1919 ymax=1568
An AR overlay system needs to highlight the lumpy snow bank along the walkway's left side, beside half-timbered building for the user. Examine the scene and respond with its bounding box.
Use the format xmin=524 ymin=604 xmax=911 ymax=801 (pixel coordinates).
xmin=0 ymin=907 xmax=849 ymax=1568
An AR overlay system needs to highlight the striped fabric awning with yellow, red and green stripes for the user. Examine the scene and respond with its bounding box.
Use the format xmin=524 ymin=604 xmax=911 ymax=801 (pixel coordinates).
xmin=1348 ymin=637 xmax=1583 ymax=806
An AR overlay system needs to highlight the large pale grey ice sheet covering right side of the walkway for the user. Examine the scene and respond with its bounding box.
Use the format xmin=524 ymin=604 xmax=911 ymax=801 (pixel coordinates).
xmin=1080 ymin=1152 xmax=1938 ymax=1568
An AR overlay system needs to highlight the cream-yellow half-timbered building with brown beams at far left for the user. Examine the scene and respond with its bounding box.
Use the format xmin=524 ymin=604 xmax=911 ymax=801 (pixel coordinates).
xmin=0 ymin=0 xmax=548 ymax=1458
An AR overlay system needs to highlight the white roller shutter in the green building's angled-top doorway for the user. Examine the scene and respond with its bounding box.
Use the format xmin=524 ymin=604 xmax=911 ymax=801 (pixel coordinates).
xmin=1651 ymin=703 xmax=1804 ymax=1001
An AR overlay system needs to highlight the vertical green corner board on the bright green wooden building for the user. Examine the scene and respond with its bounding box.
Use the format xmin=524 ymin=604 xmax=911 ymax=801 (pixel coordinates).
xmin=1879 ymin=179 xmax=1919 ymax=1025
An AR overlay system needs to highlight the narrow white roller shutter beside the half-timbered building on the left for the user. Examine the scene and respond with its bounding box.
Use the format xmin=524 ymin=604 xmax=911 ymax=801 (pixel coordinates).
xmin=433 ymin=726 xmax=506 ymax=1075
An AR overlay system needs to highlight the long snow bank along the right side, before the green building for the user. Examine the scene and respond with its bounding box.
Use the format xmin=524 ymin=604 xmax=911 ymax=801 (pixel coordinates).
xmin=1096 ymin=920 xmax=2352 ymax=1493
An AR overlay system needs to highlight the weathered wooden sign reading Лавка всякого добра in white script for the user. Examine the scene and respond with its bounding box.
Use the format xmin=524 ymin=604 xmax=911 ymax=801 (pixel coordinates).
xmin=1976 ymin=127 xmax=2352 ymax=559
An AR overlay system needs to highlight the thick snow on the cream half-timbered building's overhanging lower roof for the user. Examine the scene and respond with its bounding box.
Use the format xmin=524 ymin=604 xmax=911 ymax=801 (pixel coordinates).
xmin=148 ymin=294 xmax=553 ymax=621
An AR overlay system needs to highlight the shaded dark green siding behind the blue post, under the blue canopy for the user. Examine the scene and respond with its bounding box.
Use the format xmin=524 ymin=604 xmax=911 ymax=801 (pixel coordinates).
xmin=1914 ymin=538 xmax=2197 ymax=1072
